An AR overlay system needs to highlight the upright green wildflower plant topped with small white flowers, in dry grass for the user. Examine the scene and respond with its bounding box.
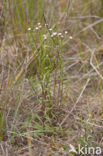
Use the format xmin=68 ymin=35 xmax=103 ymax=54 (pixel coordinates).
xmin=24 ymin=22 xmax=68 ymax=130
